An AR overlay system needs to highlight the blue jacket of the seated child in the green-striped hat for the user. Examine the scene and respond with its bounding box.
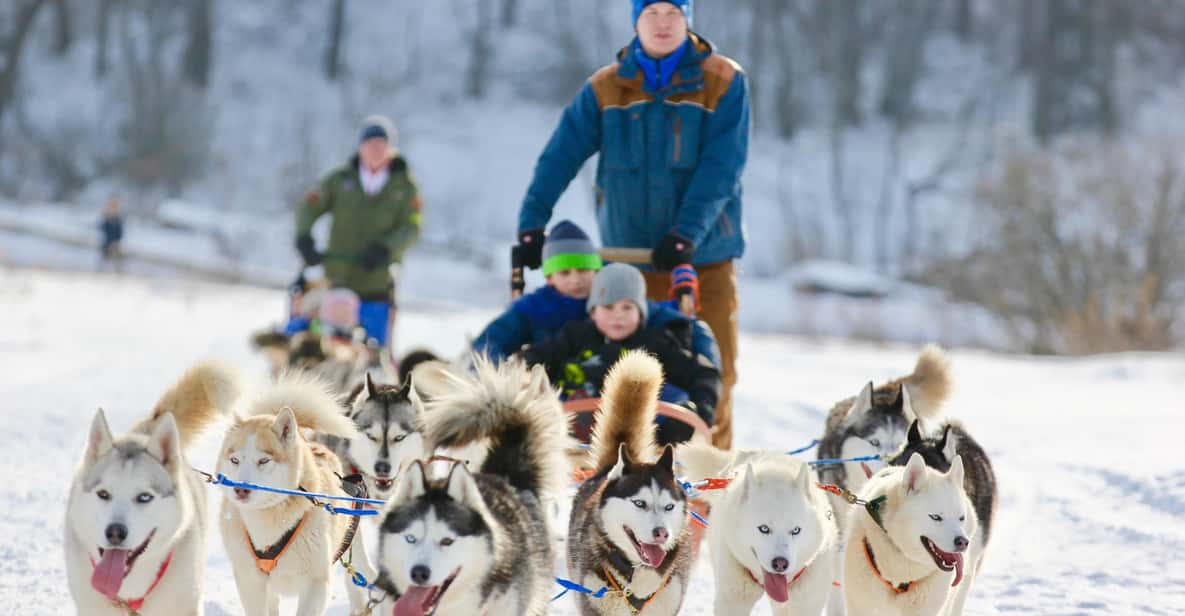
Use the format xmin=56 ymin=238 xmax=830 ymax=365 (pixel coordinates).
xmin=473 ymin=284 xmax=720 ymax=367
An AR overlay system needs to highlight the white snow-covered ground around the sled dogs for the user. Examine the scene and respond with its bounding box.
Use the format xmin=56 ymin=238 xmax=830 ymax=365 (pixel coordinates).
xmin=0 ymin=268 xmax=1185 ymax=616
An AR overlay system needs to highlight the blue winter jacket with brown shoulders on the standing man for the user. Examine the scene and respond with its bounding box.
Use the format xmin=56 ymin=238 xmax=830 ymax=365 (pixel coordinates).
xmin=519 ymin=34 xmax=749 ymax=265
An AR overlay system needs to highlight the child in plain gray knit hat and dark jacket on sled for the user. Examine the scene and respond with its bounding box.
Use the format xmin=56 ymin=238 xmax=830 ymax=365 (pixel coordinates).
xmin=523 ymin=263 xmax=720 ymax=442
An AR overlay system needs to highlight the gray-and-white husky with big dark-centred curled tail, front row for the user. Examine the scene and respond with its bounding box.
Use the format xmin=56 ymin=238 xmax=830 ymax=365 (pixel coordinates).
xmin=379 ymin=360 xmax=569 ymax=616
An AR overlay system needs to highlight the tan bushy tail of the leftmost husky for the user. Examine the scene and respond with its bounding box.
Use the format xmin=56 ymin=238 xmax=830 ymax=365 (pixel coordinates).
xmin=134 ymin=361 xmax=243 ymax=449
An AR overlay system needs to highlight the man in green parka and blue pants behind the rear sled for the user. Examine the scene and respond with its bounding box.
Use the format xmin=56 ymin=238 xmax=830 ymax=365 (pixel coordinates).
xmin=296 ymin=116 xmax=422 ymax=348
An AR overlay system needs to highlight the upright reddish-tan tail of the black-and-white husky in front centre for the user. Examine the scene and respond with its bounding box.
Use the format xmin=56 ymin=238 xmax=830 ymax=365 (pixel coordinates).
xmin=591 ymin=351 xmax=662 ymax=473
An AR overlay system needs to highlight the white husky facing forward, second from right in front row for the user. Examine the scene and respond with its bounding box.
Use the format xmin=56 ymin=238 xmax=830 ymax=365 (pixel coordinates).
xmin=675 ymin=444 xmax=839 ymax=615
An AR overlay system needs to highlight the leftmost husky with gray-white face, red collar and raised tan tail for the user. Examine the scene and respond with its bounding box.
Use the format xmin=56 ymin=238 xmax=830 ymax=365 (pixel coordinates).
xmin=65 ymin=362 xmax=239 ymax=616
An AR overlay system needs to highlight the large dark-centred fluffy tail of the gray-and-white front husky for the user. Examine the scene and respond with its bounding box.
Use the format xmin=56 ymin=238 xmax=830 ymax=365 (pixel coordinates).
xmin=414 ymin=357 xmax=570 ymax=496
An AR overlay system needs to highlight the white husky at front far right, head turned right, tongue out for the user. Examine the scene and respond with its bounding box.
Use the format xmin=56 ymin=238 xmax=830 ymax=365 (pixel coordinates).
xmin=844 ymin=453 xmax=979 ymax=616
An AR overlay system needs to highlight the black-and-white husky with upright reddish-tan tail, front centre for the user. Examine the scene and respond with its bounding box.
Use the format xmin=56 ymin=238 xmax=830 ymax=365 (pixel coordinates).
xmin=568 ymin=351 xmax=691 ymax=615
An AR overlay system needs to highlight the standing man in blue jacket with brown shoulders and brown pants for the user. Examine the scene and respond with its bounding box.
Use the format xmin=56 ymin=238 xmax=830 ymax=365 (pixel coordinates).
xmin=519 ymin=0 xmax=749 ymax=449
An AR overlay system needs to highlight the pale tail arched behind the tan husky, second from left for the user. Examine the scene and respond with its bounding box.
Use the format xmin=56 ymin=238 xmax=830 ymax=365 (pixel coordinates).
xmin=246 ymin=371 xmax=358 ymax=438
